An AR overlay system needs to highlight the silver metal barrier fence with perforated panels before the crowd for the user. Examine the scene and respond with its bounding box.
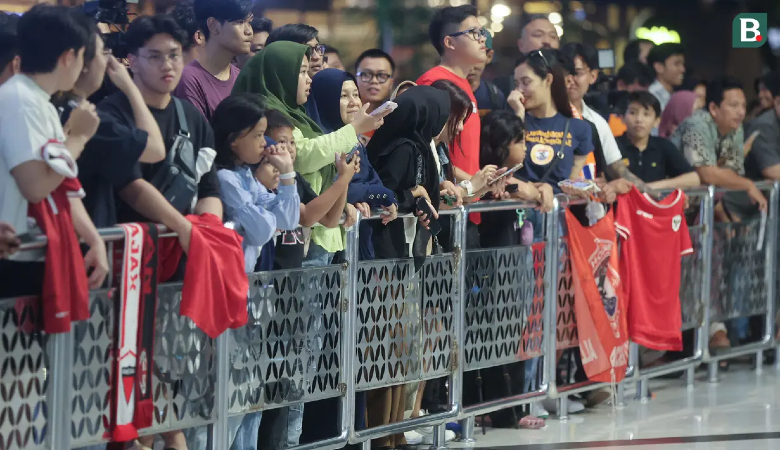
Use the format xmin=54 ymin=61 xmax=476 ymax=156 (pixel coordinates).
xmin=0 ymin=184 xmax=779 ymax=450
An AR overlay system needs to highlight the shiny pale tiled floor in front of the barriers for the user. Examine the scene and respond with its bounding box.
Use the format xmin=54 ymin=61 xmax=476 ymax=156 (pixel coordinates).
xmin=449 ymin=366 xmax=780 ymax=450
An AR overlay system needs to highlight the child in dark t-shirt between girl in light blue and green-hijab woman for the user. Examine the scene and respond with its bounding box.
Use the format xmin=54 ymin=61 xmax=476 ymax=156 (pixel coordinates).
xmin=264 ymin=110 xmax=360 ymax=270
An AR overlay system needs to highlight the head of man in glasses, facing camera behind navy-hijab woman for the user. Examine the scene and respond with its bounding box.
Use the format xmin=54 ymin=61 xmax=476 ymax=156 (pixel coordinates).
xmin=355 ymin=48 xmax=395 ymax=113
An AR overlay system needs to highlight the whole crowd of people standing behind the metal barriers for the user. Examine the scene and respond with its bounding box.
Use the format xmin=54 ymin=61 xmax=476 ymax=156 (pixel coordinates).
xmin=0 ymin=0 xmax=780 ymax=450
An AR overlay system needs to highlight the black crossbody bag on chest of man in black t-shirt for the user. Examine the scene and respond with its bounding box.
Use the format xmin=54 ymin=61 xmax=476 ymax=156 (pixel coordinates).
xmin=151 ymin=97 xmax=198 ymax=214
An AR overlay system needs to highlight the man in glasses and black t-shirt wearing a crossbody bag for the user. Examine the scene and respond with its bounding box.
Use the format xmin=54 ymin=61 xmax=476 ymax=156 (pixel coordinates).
xmin=98 ymin=15 xmax=222 ymax=246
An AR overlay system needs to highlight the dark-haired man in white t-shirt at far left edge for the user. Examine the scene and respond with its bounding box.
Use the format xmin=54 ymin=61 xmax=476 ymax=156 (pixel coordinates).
xmin=0 ymin=4 xmax=99 ymax=297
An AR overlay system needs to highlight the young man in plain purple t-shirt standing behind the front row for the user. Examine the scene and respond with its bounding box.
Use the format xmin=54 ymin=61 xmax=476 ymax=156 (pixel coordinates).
xmin=174 ymin=0 xmax=254 ymax=120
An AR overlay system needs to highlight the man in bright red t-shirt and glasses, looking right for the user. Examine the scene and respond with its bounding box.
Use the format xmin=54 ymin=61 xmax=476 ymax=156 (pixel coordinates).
xmin=417 ymin=5 xmax=487 ymax=192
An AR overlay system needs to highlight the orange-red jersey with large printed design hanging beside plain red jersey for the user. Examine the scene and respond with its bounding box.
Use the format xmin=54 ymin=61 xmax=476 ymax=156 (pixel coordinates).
xmin=566 ymin=209 xmax=628 ymax=383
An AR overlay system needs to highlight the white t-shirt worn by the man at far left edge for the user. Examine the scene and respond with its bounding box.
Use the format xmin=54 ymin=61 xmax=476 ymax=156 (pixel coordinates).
xmin=0 ymin=74 xmax=65 ymax=239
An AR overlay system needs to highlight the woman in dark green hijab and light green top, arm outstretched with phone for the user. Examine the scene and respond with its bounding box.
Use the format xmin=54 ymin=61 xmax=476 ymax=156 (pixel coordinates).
xmin=233 ymin=41 xmax=383 ymax=265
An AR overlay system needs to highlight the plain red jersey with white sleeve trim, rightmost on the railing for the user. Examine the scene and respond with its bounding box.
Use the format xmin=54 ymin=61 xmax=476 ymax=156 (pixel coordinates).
xmin=615 ymin=188 xmax=693 ymax=351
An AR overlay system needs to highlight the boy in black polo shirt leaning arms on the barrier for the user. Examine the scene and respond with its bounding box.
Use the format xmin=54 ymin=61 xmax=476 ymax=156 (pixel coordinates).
xmin=617 ymin=91 xmax=700 ymax=189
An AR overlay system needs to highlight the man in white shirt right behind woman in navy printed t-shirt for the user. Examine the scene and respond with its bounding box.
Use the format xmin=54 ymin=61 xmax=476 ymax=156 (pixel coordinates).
xmin=561 ymin=43 xmax=647 ymax=194
